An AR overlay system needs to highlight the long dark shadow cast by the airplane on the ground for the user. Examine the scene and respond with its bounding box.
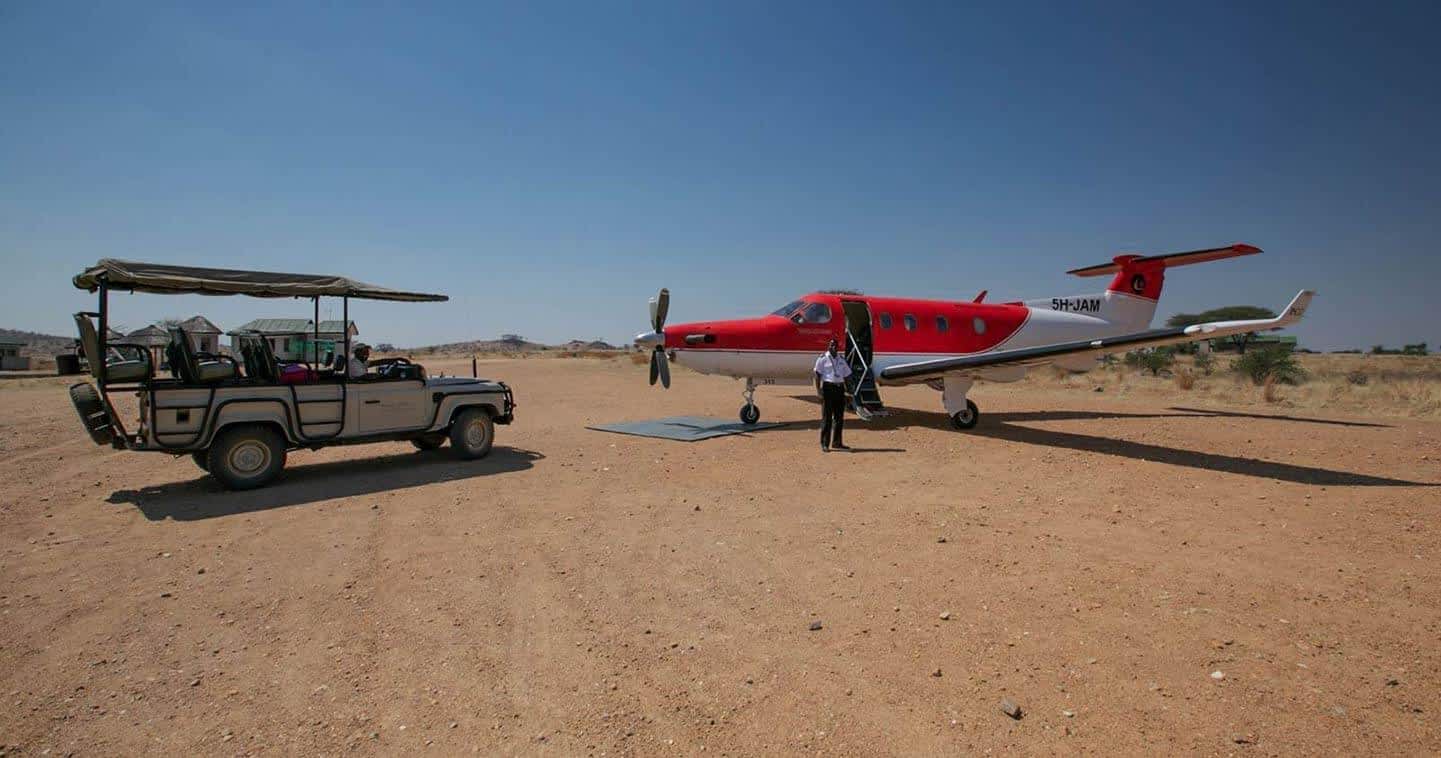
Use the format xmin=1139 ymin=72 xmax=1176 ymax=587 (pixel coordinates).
xmin=785 ymin=395 xmax=1441 ymax=487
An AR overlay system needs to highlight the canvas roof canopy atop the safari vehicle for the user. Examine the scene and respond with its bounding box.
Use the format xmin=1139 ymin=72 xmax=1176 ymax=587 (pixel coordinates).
xmin=73 ymin=258 xmax=450 ymax=303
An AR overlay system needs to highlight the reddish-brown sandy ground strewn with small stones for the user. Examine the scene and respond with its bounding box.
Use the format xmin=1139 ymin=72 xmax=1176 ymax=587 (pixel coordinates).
xmin=0 ymin=359 xmax=1441 ymax=755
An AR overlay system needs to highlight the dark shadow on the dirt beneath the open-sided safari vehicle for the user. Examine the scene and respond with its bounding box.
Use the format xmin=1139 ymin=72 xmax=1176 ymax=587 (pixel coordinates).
xmin=105 ymin=447 xmax=545 ymax=522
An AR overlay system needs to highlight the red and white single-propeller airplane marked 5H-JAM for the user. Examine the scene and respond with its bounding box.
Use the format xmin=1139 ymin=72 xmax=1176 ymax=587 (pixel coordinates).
xmin=635 ymin=245 xmax=1314 ymax=429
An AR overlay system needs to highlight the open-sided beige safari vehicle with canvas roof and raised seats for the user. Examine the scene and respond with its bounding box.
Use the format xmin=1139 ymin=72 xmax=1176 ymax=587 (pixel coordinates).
xmin=71 ymin=258 xmax=514 ymax=490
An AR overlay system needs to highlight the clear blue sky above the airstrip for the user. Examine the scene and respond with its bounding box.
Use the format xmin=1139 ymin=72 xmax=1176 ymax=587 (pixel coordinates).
xmin=0 ymin=3 xmax=1441 ymax=349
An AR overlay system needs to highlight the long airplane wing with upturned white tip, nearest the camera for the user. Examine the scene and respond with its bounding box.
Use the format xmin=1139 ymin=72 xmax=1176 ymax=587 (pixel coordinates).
xmin=880 ymin=290 xmax=1316 ymax=382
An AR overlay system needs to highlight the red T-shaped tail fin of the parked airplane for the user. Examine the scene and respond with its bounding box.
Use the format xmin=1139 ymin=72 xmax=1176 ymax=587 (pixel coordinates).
xmin=1026 ymin=244 xmax=1261 ymax=330
